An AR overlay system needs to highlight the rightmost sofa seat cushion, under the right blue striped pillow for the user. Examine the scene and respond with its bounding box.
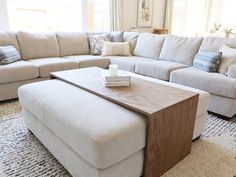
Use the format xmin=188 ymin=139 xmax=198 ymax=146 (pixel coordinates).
xmin=170 ymin=67 xmax=236 ymax=99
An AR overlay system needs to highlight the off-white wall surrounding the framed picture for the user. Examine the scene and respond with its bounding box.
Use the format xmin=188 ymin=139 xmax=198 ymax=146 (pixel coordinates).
xmin=122 ymin=0 xmax=166 ymax=32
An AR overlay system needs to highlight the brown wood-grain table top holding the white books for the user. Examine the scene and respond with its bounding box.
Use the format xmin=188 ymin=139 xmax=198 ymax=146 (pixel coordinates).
xmin=51 ymin=67 xmax=198 ymax=116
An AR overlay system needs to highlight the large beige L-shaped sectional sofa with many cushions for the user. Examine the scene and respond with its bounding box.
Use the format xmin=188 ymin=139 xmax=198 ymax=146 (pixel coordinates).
xmin=0 ymin=32 xmax=236 ymax=117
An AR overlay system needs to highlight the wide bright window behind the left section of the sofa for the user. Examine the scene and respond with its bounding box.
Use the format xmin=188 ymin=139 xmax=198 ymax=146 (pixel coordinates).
xmin=7 ymin=0 xmax=110 ymax=31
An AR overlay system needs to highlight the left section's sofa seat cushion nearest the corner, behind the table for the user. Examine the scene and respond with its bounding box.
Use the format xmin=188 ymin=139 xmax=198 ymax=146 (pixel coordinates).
xmin=64 ymin=55 xmax=110 ymax=68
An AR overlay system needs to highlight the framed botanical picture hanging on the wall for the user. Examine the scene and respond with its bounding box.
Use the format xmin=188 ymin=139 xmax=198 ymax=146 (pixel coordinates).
xmin=137 ymin=0 xmax=153 ymax=27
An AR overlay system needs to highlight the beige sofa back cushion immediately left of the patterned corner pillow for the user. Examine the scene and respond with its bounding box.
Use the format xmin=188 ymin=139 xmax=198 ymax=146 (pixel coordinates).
xmin=56 ymin=32 xmax=89 ymax=56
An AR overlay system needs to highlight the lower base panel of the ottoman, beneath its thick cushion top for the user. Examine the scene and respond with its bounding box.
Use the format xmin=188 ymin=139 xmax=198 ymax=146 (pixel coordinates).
xmin=23 ymin=109 xmax=144 ymax=177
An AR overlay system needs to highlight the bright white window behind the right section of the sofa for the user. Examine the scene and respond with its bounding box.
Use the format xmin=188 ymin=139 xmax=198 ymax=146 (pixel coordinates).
xmin=167 ymin=0 xmax=236 ymax=36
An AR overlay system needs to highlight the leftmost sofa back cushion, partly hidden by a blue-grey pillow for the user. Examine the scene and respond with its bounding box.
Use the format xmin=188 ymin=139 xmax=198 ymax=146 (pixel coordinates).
xmin=0 ymin=31 xmax=20 ymax=52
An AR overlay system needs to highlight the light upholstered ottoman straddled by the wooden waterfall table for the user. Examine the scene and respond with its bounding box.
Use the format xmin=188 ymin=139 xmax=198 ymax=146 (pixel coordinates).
xmin=18 ymin=80 xmax=209 ymax=177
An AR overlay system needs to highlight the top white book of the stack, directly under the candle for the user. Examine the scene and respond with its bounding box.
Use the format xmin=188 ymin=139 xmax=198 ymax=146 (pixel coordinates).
xmin=101 ymin=70 xmax=130 ymax=82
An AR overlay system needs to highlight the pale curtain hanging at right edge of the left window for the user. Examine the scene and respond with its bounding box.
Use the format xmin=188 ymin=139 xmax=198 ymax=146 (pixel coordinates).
xmin=110 ymin=0 xmax=122 ymax=31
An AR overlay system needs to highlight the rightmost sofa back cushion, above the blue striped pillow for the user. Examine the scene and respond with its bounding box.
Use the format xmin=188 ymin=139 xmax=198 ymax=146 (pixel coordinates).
xmin=200 ymin=37 xmax=236 ymax=52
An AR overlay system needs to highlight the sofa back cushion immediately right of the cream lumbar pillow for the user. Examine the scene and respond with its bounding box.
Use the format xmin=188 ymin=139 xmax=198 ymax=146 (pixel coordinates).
xmin=134 ymin=33 xmax=165 ymax=59
